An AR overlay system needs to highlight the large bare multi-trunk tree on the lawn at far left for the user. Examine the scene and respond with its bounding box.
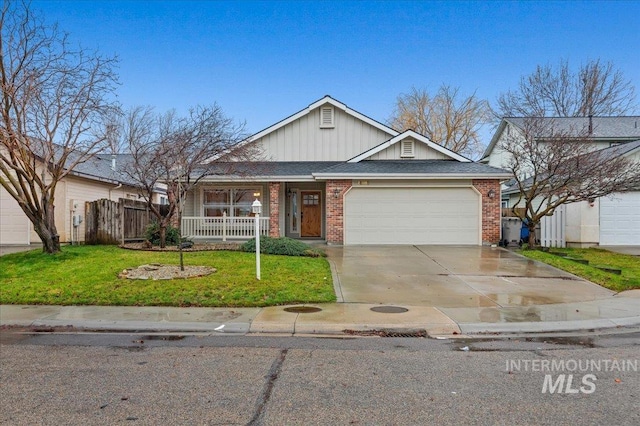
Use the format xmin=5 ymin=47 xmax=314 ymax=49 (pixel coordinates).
xmin=0 ymin=1 xmax=116 ymax=253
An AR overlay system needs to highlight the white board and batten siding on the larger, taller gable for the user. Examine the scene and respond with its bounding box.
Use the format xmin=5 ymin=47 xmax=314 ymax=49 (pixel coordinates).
xmin=255 ymin=108 xmax=393 ymax=161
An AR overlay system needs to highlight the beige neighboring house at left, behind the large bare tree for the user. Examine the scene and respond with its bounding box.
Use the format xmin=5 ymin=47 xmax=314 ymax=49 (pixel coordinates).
xmin=0 ymin=154 xmax=162 ymax=245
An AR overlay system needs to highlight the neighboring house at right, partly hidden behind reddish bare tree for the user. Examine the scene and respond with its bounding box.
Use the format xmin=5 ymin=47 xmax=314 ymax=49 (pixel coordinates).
xmin=480 ymin=116 xmax=640 ymax=247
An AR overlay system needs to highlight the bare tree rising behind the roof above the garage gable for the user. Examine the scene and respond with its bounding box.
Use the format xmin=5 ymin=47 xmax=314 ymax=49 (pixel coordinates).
xmin=388 ymin=85 xmax=489 ymax=157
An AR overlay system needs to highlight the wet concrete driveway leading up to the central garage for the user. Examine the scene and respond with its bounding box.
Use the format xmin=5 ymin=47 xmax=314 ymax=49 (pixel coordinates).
xmin=326 ymin=246 xmax=614 ymax=308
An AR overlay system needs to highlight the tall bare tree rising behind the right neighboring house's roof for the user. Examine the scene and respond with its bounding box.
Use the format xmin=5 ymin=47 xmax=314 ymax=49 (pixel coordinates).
xmin=496 ymin=59 xmax=637 ymax=117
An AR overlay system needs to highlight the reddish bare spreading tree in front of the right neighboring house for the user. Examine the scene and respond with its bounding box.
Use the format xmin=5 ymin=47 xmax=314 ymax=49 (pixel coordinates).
xmin=500 ymin=118 xmax=640 ymax=247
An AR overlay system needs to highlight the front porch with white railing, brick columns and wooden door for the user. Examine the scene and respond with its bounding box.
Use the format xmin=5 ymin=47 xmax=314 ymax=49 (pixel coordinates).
xmin=181 ymin=181 xmax=350 ymax=244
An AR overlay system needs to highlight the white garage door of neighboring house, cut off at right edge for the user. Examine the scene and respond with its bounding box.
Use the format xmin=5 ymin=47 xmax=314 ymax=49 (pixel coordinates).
xmin=600 ymin=192 xmax=640 ymax=246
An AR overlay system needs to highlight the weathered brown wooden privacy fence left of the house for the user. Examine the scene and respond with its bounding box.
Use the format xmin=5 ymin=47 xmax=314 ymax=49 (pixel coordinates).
xmin=85 ymin=198 xmax=169 ymax=244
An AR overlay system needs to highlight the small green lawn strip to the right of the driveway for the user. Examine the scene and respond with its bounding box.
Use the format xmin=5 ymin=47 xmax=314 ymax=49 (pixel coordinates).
xmin=520 ymin=248 xmax=640 ymax=291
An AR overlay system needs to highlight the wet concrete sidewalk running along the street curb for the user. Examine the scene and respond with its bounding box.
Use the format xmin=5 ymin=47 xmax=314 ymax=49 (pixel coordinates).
xmin=0 ymin=290 xmax=640 ymax=336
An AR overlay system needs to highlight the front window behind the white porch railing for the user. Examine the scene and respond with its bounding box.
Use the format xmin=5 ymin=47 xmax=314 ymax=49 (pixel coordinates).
xmin=203 ymin=188 xmax=260 ymax=217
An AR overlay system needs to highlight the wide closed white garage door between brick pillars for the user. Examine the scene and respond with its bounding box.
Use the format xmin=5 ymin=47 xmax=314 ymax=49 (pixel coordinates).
xmin=344 ymin=188 xmax=480 ymax=245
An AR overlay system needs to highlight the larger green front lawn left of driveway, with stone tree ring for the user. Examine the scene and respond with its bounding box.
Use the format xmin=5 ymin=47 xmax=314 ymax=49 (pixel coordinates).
xmin=0 ymin=246 xmax=335 ymax=307
